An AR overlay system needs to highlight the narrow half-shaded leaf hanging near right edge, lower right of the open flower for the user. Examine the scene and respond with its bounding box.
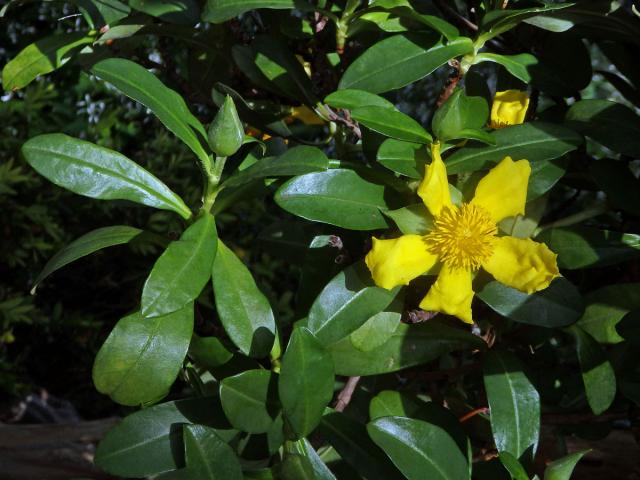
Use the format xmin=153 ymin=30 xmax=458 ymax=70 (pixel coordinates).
xmin=567 ymin=325 xmax=616 ymax=415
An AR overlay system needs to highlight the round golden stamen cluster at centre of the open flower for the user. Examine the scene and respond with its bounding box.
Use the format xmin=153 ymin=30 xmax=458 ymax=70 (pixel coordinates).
xmin=426 ymin=203 xmax=498 ymax=270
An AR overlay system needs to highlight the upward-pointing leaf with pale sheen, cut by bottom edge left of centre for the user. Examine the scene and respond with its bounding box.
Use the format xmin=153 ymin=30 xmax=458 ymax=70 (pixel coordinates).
xmin=278 ymin=438 xmax=336 ymax=480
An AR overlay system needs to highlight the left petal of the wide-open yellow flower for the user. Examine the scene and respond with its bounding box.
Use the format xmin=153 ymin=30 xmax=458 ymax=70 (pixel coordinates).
xmin=365 ymin=235 xmax=437 ymax=290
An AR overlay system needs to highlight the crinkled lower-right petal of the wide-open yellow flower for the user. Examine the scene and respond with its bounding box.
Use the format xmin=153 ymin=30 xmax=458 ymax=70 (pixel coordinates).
xmin=482 ymin=237 xmax=560 ymax=293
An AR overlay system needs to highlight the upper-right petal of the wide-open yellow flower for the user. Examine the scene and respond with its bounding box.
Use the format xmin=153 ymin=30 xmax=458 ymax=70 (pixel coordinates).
xmin=471 ymin=157 xmax=531 ymax=223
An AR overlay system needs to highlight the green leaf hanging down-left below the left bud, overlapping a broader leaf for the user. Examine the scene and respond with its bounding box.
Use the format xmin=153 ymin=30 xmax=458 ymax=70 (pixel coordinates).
xmin=141 ymin=213 xmax=218 ymax=318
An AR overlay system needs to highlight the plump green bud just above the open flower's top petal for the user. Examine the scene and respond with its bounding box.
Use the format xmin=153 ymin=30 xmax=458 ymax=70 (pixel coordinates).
xmin=431 ymin=89 xmax=491 ymax=142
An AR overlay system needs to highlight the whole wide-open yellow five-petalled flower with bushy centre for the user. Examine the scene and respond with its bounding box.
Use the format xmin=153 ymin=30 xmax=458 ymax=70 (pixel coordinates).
xmin=366 ymin=143 xmax=559 ymax=323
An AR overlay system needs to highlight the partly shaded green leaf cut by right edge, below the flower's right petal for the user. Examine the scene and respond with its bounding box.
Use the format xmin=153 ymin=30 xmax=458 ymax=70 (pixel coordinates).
xmin=578 ymin=283 xmax=640 ymax=343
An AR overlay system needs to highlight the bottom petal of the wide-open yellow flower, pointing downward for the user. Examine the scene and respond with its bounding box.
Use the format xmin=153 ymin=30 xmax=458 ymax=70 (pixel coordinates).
xmin=420 ymin=265 xmax=473 ymax=323
